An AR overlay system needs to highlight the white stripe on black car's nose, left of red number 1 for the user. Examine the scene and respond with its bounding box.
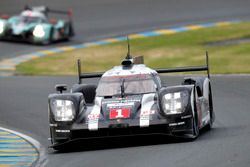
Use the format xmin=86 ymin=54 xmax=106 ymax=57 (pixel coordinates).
xmin=88 ymin=97 xmax=102 ymax=130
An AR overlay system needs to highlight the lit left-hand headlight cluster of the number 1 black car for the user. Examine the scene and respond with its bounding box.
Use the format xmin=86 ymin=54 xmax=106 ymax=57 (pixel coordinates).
xmin=52 ymin=100 xmax=75 ymax=121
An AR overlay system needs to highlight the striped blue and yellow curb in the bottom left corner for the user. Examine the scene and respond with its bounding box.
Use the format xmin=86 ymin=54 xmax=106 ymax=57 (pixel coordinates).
xmin=0 ymin=127 xmax=47 ymax=167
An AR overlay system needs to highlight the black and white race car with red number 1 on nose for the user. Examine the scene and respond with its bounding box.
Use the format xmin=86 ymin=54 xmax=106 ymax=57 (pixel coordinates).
xmin=48 ymin=51 xmax=215 ymax=148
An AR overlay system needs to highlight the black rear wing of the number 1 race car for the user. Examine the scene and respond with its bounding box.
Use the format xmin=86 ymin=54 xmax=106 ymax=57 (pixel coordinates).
xmin=77 ymin=51 xmax=210 ymax=84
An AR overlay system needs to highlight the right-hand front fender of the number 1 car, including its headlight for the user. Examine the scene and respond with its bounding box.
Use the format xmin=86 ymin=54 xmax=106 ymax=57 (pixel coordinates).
xmin=159 ymin=85 xmax=199 ymax=139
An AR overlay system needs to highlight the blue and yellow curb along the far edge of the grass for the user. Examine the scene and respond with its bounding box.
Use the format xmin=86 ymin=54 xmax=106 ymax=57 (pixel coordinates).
xmin=0 ymin=20 xmax=241 ymax=72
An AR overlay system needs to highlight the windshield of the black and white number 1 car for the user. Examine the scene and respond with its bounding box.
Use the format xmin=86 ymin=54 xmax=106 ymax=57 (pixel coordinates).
xmin=96 ymin=74 xmax=156 ymax=96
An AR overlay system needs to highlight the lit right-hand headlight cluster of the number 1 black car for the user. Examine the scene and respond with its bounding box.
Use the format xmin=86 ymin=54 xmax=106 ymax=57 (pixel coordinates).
xmin=162 ymin=91 xmax=188 ymax=115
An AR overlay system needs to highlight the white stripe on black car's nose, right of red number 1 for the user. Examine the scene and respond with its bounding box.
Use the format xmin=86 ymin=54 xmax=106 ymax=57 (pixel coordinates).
xmin=140 ymin=93 xmax=155 ymax=127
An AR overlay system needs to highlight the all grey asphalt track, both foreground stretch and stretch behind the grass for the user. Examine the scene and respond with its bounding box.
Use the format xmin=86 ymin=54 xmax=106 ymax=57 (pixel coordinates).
xmin=0 ymin=0 xmax=250 ymax=167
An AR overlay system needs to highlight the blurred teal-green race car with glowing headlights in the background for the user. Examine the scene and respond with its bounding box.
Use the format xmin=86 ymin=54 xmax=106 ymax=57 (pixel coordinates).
xmin=0 ymin=6 xmax=74 ymax=45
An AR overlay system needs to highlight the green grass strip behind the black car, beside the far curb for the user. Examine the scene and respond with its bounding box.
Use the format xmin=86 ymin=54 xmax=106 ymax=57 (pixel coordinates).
xmin=16 ymin=22 xmax=250 ymax=75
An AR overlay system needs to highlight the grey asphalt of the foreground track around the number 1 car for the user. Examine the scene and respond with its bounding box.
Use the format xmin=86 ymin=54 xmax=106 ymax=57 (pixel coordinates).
xmin=0 ymin=76 xmax=250 ymax=167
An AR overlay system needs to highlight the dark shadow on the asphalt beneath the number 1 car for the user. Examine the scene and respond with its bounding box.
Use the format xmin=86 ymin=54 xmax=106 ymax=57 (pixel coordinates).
xmin=49 ymin=130 xmax=210 ymax=154
